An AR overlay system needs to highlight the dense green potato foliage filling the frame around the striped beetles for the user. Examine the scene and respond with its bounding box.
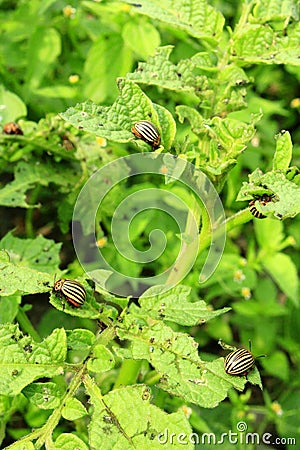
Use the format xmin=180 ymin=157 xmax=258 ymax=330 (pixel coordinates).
xmin=0 ymin=0 xmax=300 ymax=449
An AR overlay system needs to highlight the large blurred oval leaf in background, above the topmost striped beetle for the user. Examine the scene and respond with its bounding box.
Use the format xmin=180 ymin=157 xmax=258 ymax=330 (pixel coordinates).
xmin=84 ymin=33 xmax=132 ymax=103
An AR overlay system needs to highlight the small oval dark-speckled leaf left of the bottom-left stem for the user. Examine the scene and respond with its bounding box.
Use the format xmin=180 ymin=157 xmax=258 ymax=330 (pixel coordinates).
xmin=22 ymin=382 xmax=63 ymax=409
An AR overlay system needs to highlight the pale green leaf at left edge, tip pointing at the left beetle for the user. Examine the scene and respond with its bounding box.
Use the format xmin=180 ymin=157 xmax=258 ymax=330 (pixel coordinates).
xmin=0 ymin=251 xmax=53 ymax=296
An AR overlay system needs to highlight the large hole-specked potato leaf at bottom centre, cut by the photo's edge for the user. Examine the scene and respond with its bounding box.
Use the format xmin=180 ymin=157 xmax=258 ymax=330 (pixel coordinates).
xmin=86 ymin=382 xmax=194 ymax=450
